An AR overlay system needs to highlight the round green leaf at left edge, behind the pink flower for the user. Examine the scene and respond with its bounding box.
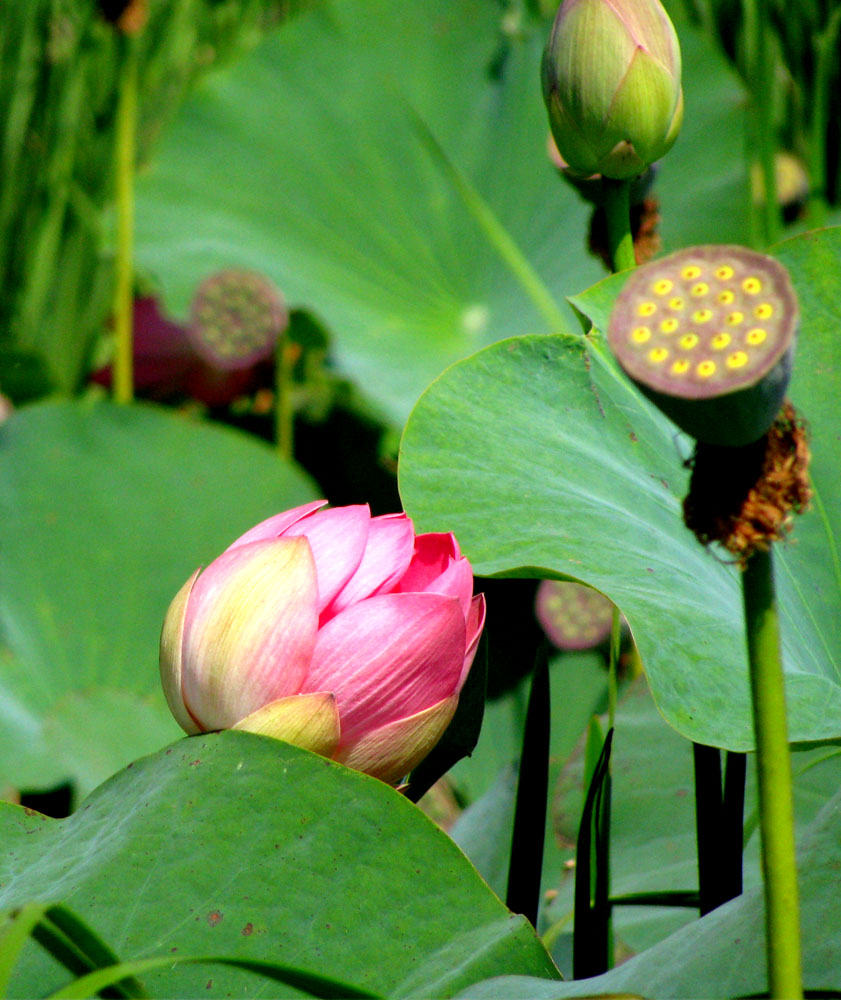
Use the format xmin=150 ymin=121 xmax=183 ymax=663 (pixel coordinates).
xmin=0 ymin=402 xmax=314 ymax=793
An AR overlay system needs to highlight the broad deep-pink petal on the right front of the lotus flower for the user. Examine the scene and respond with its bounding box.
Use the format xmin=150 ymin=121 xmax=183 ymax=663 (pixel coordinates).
xmin=302 ymin=594 xmax=466 ymax=746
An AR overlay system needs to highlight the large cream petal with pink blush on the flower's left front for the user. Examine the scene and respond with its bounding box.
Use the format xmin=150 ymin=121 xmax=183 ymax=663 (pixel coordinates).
xmin=181 ymin=538 xmax=318 ymax=730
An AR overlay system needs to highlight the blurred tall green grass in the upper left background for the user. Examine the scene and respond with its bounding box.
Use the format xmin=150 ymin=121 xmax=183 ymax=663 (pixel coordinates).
xmin=0 ymin=0 xmax=310 ymax=402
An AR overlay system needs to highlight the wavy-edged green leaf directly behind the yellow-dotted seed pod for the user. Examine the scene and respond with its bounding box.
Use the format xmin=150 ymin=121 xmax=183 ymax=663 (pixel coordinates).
xmin=400 ymin=230 xmax=841 ymax=750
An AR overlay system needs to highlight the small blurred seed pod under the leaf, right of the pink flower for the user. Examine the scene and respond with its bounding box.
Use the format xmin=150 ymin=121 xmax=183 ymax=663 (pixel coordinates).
xmin=534 ymin=580 xmax=613 ymax=650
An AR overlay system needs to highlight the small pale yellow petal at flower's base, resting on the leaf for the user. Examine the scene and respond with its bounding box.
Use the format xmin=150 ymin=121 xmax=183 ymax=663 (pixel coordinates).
xmin=233 ymin=692 xmax=340 ymax=757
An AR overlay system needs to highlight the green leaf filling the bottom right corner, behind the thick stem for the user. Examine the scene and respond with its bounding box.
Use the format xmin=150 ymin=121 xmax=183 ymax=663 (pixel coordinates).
xmin=462 ymin=793 xmax=841 ymax=1000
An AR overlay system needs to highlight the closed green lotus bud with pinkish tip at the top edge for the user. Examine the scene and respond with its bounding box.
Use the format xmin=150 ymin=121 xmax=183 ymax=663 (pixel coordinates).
xmin=542 ymin=0 xmax=683 ymax=180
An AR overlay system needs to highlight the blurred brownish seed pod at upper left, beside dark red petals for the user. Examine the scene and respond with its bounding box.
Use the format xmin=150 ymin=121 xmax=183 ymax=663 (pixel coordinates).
xmin=189 ymin=270 xmax=289 ymax=371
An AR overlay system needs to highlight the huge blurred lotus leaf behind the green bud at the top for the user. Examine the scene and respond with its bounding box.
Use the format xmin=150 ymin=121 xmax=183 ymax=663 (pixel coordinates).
xmin=137 ymin=0 xmax=744 ymax=427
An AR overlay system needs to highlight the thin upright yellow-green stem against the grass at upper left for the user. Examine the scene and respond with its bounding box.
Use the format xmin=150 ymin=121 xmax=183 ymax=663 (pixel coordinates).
xmin=114 ymin=37 xmax=137 ymax=403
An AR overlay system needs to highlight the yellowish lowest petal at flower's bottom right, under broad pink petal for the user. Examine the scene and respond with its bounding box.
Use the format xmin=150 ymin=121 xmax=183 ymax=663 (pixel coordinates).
xmin=335 ymin=695 xmax=458 ymax=785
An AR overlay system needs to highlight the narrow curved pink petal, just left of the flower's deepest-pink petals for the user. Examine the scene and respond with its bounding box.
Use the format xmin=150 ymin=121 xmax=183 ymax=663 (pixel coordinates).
xmin=321 ymin=514 xmax=415 ymax=624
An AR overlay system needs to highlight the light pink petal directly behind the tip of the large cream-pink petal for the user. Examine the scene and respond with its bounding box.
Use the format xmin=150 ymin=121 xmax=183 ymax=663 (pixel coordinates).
xmin=284 ymin=504 xmax=371 ymax=612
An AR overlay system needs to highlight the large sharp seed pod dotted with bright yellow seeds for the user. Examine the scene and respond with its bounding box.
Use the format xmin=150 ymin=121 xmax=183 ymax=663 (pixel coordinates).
xmin=608 ymin=246 xmax=798 ymax=446
